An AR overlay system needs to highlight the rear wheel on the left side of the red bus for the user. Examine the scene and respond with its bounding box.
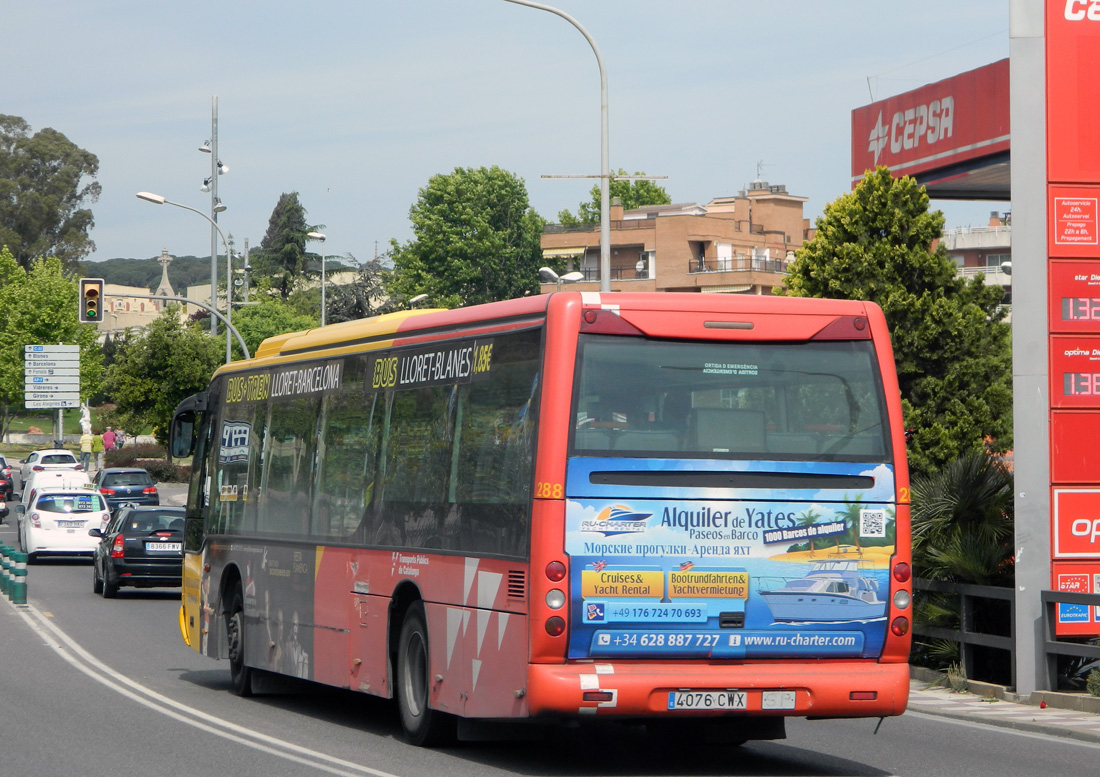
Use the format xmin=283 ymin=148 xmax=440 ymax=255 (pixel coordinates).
xmin=396 ymin=602 xmax=455 ymax=747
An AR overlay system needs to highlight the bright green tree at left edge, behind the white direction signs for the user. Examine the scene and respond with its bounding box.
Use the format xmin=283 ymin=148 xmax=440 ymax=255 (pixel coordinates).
xmin=0 ymin=248 xmax=102 ymax=436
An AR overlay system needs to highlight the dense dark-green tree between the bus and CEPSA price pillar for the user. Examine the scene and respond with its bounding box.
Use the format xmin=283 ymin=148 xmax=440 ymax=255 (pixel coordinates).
xmin=777 ymin=167 xmax=1012 ymax=473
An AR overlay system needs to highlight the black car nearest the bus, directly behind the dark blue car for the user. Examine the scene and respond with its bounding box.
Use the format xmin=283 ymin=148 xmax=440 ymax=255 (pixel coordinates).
xmin=88 ymin=505 xmax=184 ymax=599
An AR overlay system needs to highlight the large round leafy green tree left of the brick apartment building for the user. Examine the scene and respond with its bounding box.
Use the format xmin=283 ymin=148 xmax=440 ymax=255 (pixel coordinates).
xmin=389 ymin=165 xmax=543 ymax=307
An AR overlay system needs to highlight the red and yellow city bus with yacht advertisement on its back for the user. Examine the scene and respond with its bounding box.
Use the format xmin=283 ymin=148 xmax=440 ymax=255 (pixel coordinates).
xmin=172 ymin=292 xmax=911 ymax=744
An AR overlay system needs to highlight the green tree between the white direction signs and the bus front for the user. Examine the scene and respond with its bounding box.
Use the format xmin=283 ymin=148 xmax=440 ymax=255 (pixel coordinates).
xmin=105 ymin=304 xmax=226 ymax=445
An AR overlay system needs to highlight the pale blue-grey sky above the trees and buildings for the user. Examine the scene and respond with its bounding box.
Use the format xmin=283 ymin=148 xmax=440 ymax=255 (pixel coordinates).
xmin=0 ymin=0 xmax=1011 ymax=266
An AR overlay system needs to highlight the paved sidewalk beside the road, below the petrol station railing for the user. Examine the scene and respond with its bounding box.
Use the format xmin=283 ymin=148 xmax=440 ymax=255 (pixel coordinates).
xmin=909 ymin=667 xmax=1100 ymax=744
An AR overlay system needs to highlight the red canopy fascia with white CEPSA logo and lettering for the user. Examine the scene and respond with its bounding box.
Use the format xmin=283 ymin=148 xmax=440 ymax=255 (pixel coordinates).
xmin=851 ymin=59 xmax=1009 ymax=186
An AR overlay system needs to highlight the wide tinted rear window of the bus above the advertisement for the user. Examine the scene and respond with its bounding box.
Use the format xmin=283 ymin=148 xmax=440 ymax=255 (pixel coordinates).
xmin=573 ymin=335 xmax=891 ymax=462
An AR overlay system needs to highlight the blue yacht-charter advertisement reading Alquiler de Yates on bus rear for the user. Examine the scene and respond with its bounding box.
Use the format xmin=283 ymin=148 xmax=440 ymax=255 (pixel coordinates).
xmin=565 ymin=459 xmax=894 ymax=659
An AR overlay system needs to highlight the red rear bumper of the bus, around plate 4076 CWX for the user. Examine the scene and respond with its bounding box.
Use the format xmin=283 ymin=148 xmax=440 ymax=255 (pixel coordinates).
xmin=526 ymin=663 xmax=909 ymax=718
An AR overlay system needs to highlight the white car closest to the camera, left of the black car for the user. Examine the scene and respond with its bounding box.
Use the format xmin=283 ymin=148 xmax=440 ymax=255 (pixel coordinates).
xmin=15 ymin=488 xmax=111 ymax=561
